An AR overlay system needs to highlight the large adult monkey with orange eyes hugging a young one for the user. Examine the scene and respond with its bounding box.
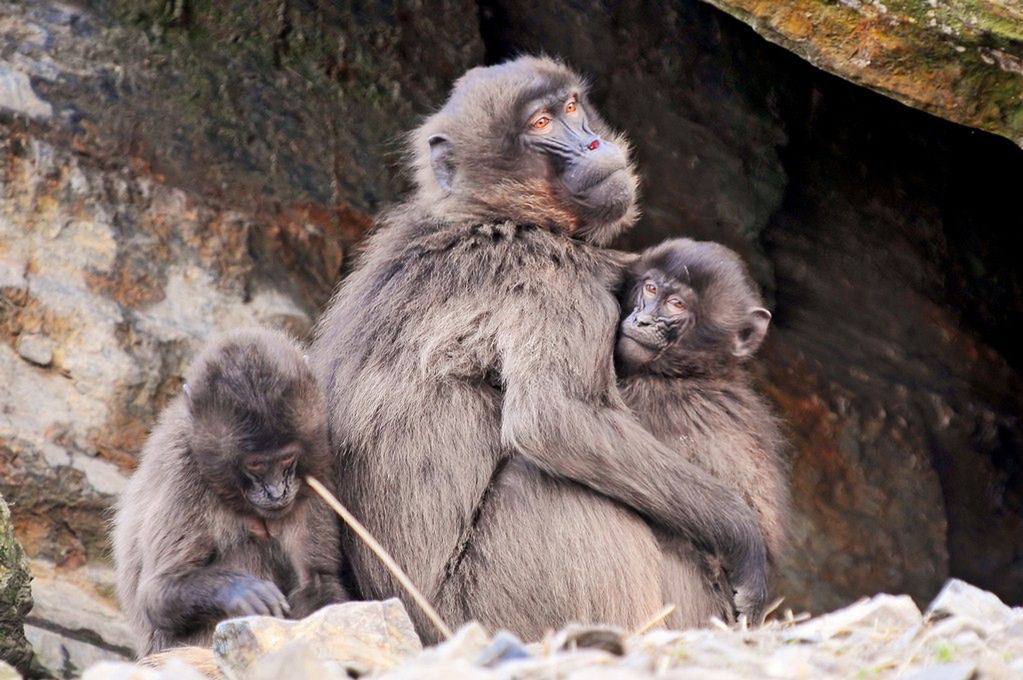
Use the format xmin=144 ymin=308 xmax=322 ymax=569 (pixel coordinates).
xmin=312 ymin=57 xmax=766 ymax=638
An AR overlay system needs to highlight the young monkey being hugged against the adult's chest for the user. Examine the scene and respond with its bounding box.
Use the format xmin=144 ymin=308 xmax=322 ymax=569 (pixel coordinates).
xmin=616 ymin=239 xmax=789 ymax=627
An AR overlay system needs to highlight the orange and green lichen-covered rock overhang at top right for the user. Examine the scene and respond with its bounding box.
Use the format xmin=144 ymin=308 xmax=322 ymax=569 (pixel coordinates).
xmin=706 ymin=0 xmax=1023 ymax=146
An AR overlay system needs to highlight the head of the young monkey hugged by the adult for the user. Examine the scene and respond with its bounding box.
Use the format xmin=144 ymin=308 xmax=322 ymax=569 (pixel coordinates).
xmin=615 ymin=238 xmax=770 ymax=375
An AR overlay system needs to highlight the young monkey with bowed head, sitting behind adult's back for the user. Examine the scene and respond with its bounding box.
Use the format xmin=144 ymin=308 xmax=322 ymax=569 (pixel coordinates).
xmin=113 ymin=329 xmax=346 ymax=655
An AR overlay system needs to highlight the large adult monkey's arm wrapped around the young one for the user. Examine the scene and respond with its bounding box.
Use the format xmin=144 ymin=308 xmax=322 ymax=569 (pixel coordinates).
xmin=498 ymin=301 xmax=767 ymax=617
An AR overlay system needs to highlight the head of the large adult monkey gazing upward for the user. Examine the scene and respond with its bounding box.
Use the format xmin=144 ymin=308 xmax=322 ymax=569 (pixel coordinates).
xmin=412 ymin=57 xmax=638 ymax=243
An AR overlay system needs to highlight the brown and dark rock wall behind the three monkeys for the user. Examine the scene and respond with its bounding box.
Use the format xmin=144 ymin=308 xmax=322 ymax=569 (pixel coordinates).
xmin=0 ymin=0 xmax=1023 ymax=666
